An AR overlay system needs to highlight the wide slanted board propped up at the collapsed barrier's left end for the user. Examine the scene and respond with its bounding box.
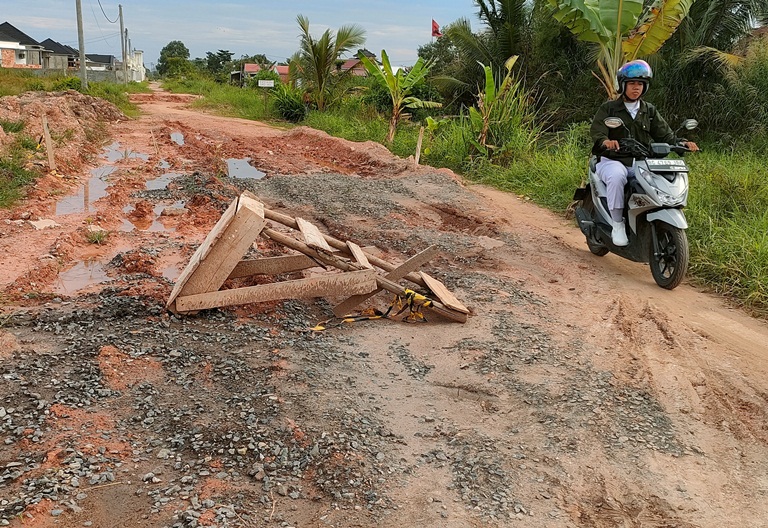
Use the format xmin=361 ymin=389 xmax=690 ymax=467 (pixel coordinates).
xmin=167 ymin=195 xmax=265 ymax=311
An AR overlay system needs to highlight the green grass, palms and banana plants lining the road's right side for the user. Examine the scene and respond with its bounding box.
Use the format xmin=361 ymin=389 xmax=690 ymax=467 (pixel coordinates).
xmin=0 ymin=0 xmax=768 ymax=314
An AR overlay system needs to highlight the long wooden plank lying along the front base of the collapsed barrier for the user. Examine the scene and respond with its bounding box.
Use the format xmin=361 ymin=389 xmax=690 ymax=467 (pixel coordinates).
xmin=176 ymin=270 xmax=376 ymax=312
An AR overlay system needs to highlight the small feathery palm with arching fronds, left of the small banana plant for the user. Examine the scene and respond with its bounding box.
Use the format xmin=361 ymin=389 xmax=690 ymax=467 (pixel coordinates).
xmin=292 ymin=15 xmax=365 ymax=110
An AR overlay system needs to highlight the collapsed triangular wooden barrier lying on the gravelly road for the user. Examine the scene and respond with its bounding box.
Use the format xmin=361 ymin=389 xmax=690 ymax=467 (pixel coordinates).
xmin=166 ymin=191 xmax=469 ymax=323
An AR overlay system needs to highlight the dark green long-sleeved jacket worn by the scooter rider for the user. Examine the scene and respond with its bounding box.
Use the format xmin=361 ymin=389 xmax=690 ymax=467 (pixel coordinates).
xmin=589 ymin=97 xmax=682 ymax=167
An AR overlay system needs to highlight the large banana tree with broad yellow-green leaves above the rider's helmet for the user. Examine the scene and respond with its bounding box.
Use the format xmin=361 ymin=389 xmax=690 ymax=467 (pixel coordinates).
xmin=549 ymin=0 xmax=695 ymax=98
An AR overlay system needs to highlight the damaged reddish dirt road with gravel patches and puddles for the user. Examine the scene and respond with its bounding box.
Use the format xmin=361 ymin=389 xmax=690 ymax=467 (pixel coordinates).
xmin=0 ymin=84 xmax=768 ymax=528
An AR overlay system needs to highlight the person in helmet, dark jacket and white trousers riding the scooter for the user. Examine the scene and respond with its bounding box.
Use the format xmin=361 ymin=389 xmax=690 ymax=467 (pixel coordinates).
xmin=590 ymin=60 xmax=699 ymax=246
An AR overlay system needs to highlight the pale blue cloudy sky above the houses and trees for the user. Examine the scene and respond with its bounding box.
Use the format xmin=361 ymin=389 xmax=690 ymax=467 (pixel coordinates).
xmin=0 ymin=0 xmax=478 ymax=69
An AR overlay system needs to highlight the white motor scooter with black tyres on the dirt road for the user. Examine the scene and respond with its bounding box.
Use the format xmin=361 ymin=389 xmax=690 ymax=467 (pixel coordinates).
xmin=573 ymin=117 xmax=698 ymax=290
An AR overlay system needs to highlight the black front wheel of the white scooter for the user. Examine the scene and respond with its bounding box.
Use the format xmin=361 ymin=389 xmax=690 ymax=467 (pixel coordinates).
xmin=648 ymin=222 xmax=690 ymax=290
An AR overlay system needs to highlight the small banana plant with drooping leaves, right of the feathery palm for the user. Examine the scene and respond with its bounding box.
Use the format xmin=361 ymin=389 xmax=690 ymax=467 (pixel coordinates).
xmin=357 ymin=50 xmax=442 ymax=143
